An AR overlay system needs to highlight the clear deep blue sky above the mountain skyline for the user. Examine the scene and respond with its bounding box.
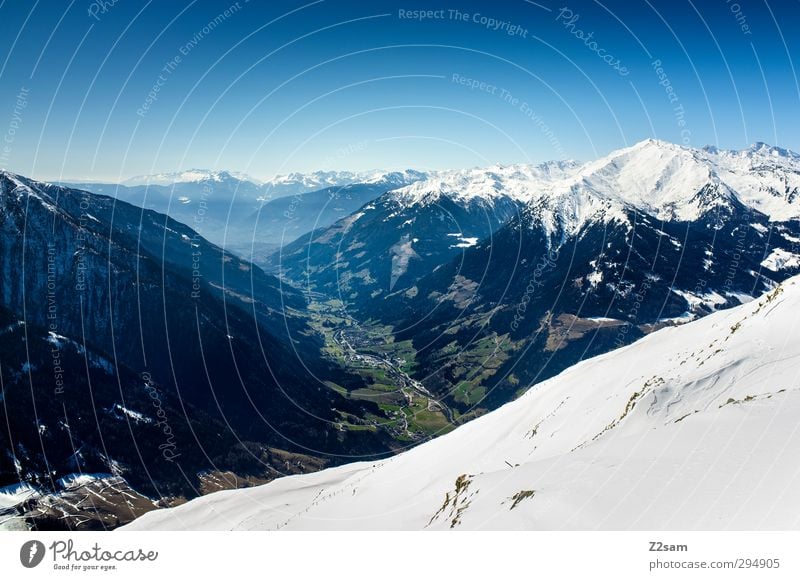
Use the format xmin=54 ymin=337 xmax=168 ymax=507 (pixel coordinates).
xmin=0 ymin=0 xmax=800 ymax=181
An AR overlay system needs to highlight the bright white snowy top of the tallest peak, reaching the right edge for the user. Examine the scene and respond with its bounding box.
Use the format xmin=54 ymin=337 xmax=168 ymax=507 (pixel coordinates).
xmin=530 ymin=139 xmax=800 ymax=235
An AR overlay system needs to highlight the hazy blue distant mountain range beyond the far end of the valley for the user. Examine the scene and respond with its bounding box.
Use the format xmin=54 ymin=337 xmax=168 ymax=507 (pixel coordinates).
xmin=64 ymin=169 xmax=428 ymax=262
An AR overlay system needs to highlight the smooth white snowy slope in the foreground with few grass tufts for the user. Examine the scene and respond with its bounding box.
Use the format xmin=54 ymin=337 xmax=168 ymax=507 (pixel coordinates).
xmin=127 ymin=277 xmax=800 ymax=530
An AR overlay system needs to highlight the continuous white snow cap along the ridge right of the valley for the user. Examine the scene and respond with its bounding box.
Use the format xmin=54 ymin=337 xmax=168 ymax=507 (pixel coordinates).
xmin=380 ymin=139 xmax=800 ymax=239
